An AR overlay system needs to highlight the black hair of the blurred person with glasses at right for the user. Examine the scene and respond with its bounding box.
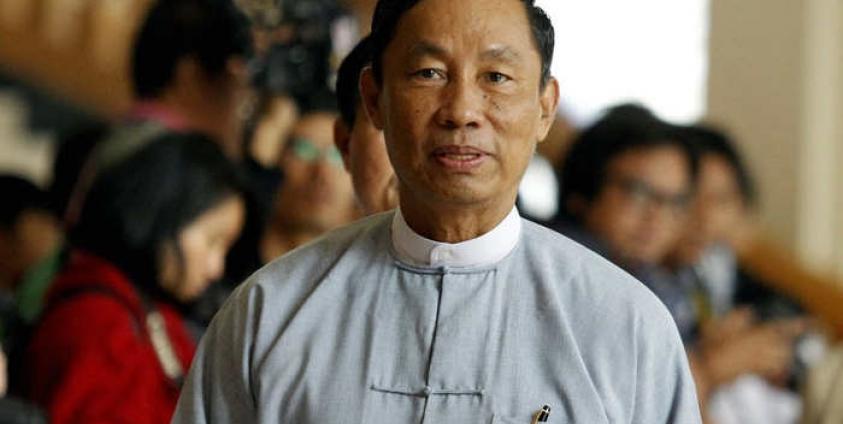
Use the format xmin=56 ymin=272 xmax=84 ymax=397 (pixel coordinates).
xmin=557 ymin=104 xmax=699 ymax=221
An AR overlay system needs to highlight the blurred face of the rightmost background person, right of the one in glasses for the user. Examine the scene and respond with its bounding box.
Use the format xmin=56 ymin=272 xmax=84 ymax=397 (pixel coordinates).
xmin=672 ymin=154 xmax=746 ymax=265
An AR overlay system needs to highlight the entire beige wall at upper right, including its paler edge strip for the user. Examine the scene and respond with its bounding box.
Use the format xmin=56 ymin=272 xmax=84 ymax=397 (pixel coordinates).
xmin=708 ymin=0 xmax=843 ymax=272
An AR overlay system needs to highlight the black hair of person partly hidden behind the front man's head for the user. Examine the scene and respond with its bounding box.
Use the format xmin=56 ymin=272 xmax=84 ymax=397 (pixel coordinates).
xmin=337 ymin=36 xmax=372 ymax=128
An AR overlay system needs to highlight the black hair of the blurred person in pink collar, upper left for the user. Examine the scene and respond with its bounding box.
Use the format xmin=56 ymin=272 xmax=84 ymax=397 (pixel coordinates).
xmin=131 ymin=0 xmax=250 ymax=99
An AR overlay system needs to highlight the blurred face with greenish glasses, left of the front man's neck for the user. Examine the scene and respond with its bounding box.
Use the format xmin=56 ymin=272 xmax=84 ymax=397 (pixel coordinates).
xmin=275 ymin=113 xmax=354 ymax=233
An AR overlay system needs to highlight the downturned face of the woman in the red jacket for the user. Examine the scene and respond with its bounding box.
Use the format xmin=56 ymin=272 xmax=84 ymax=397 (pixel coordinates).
xmin=160 ymin=196 xmax=246 ymax=303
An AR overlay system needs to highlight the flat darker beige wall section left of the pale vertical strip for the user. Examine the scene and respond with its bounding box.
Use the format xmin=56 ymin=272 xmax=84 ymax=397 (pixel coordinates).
xmin=707 ymin=0 xmax=803 ymax=243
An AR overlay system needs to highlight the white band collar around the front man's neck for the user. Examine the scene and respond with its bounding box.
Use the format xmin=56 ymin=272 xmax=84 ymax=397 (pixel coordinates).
xmin=392 ymin=206 xmax=521 ymax=268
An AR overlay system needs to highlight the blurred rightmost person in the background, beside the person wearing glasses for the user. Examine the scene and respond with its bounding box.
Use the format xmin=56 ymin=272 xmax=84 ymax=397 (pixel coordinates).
xmin=664 ymin=125 xmax=806 ymax=424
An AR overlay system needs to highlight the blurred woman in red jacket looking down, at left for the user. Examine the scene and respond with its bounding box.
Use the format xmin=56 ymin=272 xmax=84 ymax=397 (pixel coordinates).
xmin=27 ymin=134 xmax=244 ymax=423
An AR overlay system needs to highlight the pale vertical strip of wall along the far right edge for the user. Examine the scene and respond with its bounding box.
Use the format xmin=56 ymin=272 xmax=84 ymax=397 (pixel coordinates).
xmin=797 ymin=0 xmax=843 ymax=275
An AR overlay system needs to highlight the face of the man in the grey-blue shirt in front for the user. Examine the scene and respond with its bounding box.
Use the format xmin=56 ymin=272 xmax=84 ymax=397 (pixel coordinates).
xmin=362 ymin=0 xmax=558 ymax=210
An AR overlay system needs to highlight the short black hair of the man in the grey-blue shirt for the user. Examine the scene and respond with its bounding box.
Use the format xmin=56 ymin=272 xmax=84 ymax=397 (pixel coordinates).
xmin=371 ymin=0 xmax=555 ymax=88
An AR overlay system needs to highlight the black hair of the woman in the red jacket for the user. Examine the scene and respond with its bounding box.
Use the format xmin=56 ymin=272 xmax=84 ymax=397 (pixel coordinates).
xmin=70 ymin=133 xmax=244 ymax=294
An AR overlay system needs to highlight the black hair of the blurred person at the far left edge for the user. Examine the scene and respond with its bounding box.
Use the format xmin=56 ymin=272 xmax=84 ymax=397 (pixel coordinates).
xmin=0 ymin=174 xmax=50 ymax=231
